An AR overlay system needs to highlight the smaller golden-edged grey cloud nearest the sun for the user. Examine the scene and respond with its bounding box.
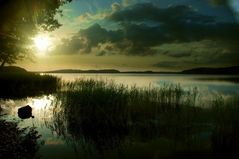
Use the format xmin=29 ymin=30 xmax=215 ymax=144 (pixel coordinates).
xmin=53 ymin=24 xmax=123 ymax=55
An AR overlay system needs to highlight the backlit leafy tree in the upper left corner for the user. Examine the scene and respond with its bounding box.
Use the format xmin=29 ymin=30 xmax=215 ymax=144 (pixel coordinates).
xmin=0 ymin=0 xmax=72 ymax=67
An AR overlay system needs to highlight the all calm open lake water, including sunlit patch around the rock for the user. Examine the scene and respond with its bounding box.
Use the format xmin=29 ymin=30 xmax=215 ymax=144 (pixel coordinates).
xmin=0 ymin=74 xmax=239 ymax=159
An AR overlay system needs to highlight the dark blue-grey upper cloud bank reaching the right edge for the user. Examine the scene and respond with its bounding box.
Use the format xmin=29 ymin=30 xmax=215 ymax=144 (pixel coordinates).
xmin=108 ymin=3 xmax=239 ymax=54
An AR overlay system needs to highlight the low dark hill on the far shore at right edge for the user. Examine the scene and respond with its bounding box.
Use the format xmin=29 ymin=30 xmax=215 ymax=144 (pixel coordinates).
xmin=181 ymin=66 xmax=239 ymax=75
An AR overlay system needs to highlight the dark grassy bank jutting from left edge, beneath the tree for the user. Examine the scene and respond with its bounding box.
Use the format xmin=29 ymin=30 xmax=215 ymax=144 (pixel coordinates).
xmin=0 ymin=72 xmax=60 ymax=99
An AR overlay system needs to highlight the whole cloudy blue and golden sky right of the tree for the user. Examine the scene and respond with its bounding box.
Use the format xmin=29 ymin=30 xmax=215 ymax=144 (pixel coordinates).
xmin=18 ymin=0 xmax=239 ymax=71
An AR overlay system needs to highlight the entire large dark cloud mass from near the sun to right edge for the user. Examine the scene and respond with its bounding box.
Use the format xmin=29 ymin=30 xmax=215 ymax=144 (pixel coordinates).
xmin=52 ymin=3 xmax=239 ymax=57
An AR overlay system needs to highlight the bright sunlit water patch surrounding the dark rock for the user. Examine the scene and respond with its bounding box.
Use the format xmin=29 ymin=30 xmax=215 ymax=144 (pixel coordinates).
xmin=0 ymin=95 xmax=67 ymax=158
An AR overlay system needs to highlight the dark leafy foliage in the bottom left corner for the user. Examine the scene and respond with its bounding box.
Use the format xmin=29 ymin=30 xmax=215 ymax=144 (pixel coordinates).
xmin=0 ymin=119 xmax=40 ymax=159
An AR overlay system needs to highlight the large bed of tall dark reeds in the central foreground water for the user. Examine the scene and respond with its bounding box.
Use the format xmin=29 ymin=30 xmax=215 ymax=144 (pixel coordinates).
xmin=54 ymin=79 xmax=218 ymax=154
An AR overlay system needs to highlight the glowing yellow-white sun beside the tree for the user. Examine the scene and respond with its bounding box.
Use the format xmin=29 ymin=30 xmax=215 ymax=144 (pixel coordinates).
xmin=33 ymin=34 xmax=52 ymax=54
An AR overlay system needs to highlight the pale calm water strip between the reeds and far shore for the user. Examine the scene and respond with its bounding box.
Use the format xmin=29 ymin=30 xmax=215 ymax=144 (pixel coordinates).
xmin=51 ymin=74 xmax=239 ymax=94
